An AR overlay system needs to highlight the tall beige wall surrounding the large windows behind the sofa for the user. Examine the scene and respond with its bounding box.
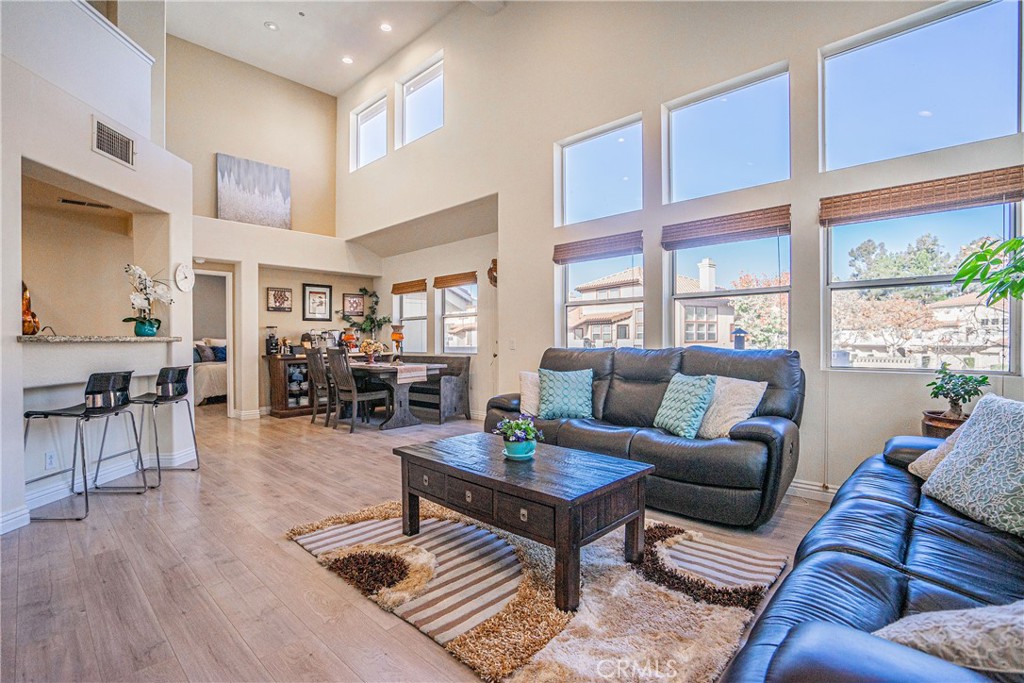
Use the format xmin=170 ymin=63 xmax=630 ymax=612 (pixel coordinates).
xmin=338 ymin=2 xmax=1024 ymax=495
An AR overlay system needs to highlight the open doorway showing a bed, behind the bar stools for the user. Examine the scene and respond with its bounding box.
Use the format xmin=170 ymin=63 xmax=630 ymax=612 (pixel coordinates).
xmin=193 ymin=270 xmax=234 ymax=419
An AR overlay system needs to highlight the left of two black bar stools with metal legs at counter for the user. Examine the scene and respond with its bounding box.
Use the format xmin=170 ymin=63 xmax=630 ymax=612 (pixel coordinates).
xmin=25 ymin=370 xmax=148 ymax=521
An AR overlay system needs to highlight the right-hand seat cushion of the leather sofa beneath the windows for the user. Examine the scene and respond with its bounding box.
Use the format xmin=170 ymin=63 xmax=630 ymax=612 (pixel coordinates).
xmin=630 ymin=428 xmax=768 ymax=488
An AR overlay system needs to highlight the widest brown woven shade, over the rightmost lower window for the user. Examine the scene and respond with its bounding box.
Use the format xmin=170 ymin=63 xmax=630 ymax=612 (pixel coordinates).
xmin=818 ymin=166 xmax=1024 ymax=227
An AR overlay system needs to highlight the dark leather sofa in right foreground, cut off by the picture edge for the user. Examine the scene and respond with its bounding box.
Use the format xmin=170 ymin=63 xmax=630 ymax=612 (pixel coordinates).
xmin=719 ymin=436 xmax=1024 ymax=683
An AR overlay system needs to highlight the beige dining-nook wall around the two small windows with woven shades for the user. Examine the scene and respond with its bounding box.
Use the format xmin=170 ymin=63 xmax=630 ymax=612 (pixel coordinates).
xmin=376 ymin=233 xmax=499 ymax=417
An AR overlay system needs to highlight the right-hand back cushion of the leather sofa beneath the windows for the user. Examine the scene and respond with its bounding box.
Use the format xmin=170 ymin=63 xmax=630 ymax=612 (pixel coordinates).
xmin=683 ymin=346 xmax=804 ymax=425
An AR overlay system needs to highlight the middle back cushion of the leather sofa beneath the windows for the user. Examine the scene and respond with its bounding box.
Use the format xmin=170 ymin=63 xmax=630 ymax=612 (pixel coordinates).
xmin=595 ymin=348 xmax=692 ymax=427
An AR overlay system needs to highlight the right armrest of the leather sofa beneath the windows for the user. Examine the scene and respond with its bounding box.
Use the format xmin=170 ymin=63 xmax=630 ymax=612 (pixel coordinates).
xmin=729 ymin=415 xmax=800 ymax=528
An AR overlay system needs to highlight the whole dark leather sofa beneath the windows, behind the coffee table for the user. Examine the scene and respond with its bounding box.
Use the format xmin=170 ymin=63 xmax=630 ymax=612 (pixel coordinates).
xmin=484 ymin=346 xmax=805 ymax=527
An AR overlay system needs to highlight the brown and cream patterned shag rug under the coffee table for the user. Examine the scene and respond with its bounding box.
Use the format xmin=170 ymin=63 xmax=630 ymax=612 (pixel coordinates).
xmin=288 ymin=501 xmax=785 ymax=683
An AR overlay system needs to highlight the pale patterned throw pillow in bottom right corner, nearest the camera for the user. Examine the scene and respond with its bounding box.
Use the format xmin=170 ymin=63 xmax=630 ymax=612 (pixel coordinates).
xmin=872 ymin=600 xmax=1024 ymax=674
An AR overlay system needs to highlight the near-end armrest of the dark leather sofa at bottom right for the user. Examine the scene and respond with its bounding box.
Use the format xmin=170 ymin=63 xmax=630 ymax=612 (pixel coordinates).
xmin=765 ymin=622 xmax=989 ymax=683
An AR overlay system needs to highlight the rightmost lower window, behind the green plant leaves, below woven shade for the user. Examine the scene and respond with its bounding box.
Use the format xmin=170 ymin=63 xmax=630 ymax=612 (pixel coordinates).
xmin=828 ymin=204 xmax=1019 ymax=373
